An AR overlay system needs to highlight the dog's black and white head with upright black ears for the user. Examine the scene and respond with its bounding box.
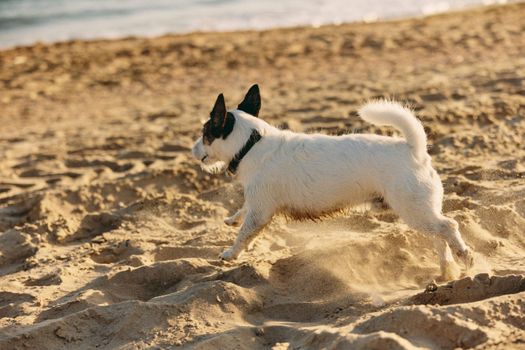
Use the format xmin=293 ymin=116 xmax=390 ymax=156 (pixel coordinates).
xmin=192 ymin=84 xmax=261 ymax=174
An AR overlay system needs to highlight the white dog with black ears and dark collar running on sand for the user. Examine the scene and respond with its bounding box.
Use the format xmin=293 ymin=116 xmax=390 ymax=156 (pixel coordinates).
xmin=192 ymin=85 xmax=472 ymax=269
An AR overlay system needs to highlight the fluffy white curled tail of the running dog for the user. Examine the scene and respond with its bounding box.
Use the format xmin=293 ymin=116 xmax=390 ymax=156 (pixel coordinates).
xmin=359 ymin=101 xmax=427 ymax=160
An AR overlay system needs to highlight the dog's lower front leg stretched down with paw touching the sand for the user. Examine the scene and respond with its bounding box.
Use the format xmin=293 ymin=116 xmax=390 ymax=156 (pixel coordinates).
xmin=219 ymin=210 xmax=272 ymax=260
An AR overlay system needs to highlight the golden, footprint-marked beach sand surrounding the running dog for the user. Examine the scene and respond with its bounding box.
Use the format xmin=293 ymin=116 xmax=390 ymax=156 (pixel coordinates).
xmin=0 ymin=4 xmax=525 ymax=349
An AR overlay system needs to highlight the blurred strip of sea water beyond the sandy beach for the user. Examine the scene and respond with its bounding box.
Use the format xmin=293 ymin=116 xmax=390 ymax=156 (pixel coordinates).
xmin=0 ymin=0 xmax=506 ymax=48
